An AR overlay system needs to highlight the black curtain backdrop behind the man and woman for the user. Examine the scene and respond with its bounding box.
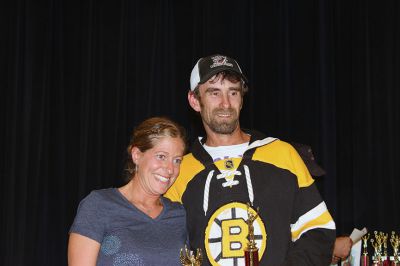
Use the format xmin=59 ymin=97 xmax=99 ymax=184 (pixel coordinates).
xmin=0 ymin=0 xmax=400 ymax=266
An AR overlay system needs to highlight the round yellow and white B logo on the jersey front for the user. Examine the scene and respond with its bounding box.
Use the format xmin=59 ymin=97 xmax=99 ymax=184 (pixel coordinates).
xmin=204 ymin=202 xmax=267 ymax=266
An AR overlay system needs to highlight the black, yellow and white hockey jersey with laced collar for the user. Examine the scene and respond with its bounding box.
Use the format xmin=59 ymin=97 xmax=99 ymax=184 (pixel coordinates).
xmin=165 ymin=131 xmax=335 ymax=266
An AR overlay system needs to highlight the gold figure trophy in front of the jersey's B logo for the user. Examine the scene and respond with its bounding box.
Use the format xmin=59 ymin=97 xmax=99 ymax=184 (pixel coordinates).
xmin=244 ymin=203 xmax=260 ymax=266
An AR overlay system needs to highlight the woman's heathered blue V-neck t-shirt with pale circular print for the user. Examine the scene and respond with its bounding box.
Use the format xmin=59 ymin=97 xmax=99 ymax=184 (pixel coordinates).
xmin=70 ymin=188 xmax=187 ymax=266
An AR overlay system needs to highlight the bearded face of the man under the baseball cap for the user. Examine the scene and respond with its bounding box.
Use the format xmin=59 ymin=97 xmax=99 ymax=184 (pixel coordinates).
xmin=195 ymin=78 xmax=243 ymax=134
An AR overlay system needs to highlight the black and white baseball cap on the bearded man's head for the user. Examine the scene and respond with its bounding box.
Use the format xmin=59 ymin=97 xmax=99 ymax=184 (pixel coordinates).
xmin=190 ymin=54 xmax=247 ymax=91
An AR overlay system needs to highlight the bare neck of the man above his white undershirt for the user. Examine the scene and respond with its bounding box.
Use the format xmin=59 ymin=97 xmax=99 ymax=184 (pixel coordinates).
xmin=205 ymin=127 xmax=250 ymax=147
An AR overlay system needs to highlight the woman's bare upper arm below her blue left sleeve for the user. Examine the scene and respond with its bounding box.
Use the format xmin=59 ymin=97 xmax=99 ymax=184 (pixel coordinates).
xmin=68 ymin=233 xmax=100 ymax=266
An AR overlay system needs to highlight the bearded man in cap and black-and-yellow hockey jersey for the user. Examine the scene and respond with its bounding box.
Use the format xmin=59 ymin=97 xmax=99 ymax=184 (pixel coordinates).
xmin=165 ymin=55 xmax=335 ymax=265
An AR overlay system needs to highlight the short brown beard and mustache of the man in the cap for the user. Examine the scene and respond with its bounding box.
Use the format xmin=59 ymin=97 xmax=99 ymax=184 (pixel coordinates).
xmin=204 ymin=108 xmax=239 ymax=135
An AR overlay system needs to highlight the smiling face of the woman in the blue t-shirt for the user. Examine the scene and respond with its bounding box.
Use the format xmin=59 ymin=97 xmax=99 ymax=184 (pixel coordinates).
xmin=131 ymin=137 xmax=185 ymax=196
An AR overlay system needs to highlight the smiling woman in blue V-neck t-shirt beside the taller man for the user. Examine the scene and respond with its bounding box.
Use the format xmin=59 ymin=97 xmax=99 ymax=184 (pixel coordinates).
xmin=68 ymin=117 xmax=187 ymax=266
